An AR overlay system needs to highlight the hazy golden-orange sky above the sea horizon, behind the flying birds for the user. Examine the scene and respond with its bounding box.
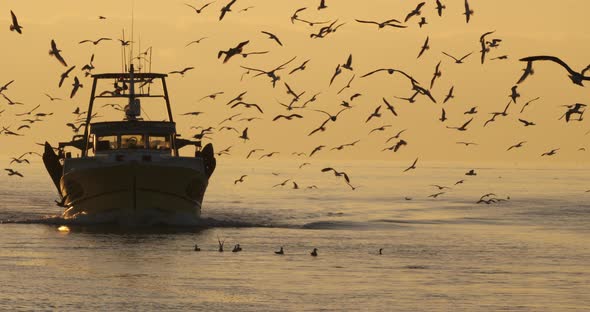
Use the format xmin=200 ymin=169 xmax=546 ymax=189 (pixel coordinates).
xmin=0 ymin=0 xmax=590 ymax=163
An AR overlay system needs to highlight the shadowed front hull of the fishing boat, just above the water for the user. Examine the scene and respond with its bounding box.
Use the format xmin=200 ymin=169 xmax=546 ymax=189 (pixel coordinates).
xmin=60 ymin=158 xmax=208 ymax=224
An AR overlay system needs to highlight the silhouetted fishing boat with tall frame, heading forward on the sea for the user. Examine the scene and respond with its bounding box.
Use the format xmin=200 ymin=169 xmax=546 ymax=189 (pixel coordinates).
xmin=43 ymin=65 xmax=216 ymax=224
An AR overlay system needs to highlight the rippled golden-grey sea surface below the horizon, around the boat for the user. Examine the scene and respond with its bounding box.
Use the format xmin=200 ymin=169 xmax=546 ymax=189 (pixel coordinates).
xmin=0 ymin=159 xmax=590 ymax=311
